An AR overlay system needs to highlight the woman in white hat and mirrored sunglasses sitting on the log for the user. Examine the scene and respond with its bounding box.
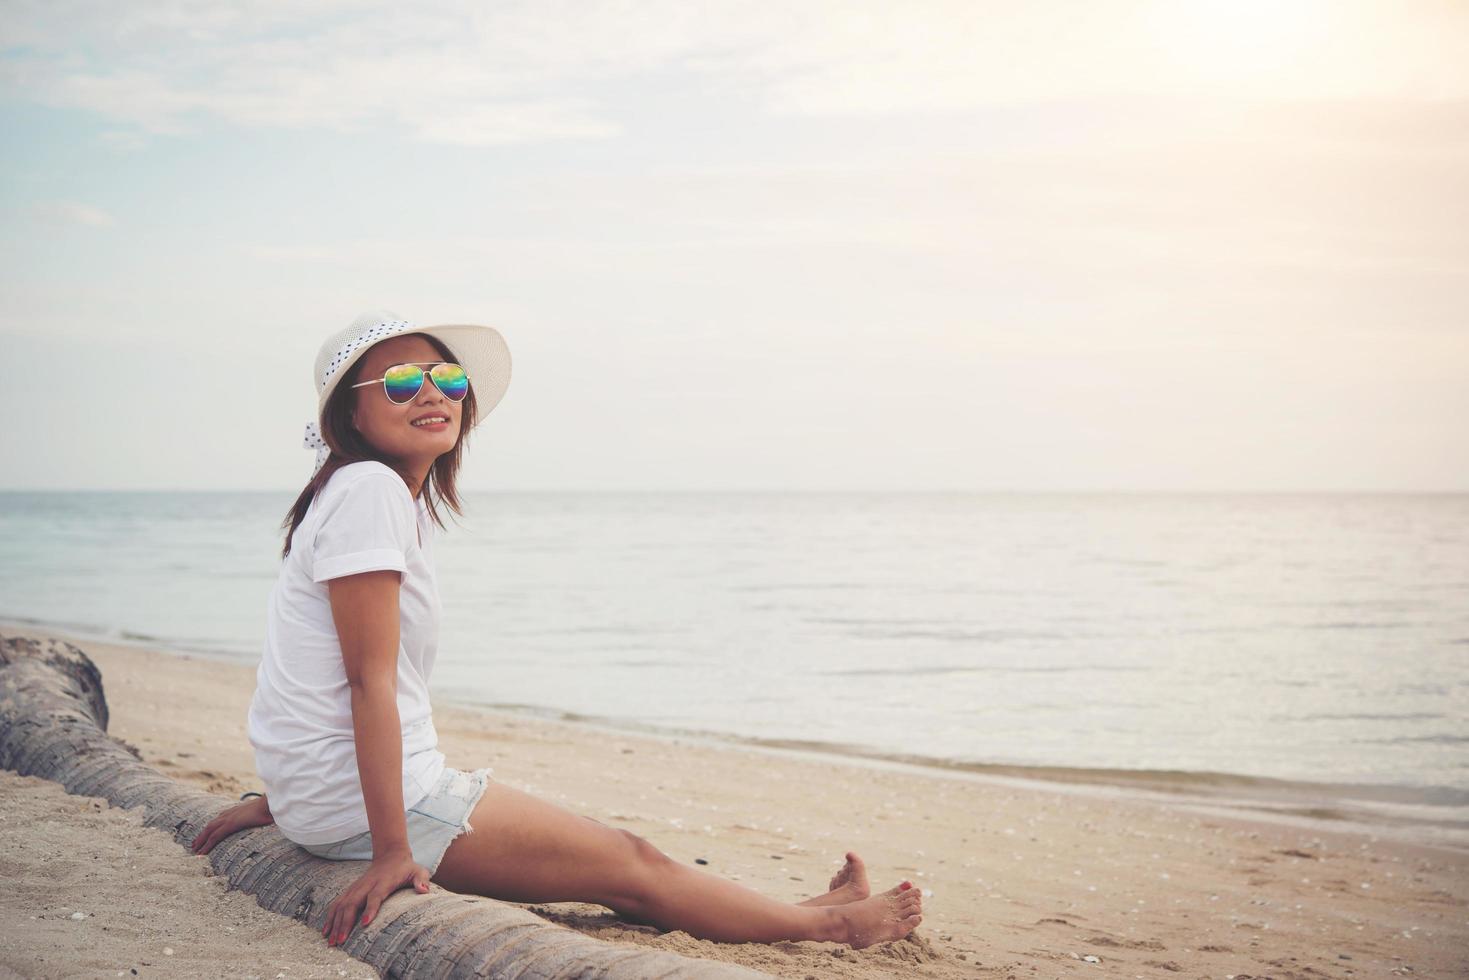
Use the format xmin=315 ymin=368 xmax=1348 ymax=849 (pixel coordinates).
xmin=192 ymin=313 xmax=921 ymax=948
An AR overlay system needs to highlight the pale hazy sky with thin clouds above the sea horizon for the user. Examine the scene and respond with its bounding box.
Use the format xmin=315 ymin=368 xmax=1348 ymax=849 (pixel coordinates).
xmin=0 ymin=0 xmax=1469 ymax=492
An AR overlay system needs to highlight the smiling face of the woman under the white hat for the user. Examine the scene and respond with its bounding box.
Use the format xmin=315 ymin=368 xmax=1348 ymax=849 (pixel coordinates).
xmin=353 ymin=334 xmax=464 ymax=472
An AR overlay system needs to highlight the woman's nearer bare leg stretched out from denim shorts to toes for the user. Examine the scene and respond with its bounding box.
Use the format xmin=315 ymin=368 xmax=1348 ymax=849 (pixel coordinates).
xmin=433 ymin=780 xmax=921 ymax=946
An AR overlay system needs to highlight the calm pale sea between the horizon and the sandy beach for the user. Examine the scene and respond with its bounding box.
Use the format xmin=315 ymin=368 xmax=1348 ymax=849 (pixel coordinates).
xmin=0 ymin=491 xmax=1469 ymax=848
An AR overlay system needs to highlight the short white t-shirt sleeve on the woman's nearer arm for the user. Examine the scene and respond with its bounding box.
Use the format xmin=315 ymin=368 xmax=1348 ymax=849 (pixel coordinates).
xmin=311 ymin=473 xmax=417 ymax=582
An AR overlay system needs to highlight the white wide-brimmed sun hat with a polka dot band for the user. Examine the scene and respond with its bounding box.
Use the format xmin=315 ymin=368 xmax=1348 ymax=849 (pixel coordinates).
xmin=301 ymin=310 xmax=510 ymax=476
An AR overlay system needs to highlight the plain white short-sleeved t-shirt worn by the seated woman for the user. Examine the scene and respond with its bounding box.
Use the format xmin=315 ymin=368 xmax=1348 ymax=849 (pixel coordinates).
xmin=247 ymin=460 xmax=444 ymax=843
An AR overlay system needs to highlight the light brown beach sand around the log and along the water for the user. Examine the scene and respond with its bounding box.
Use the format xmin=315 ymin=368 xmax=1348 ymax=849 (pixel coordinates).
xmin=0 ymin=626 xmax=1469 ymax=980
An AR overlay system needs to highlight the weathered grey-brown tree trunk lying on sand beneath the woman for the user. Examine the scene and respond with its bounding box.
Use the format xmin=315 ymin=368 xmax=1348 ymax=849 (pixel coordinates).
xmin=0 ymin=636 xmax=768 ymax=980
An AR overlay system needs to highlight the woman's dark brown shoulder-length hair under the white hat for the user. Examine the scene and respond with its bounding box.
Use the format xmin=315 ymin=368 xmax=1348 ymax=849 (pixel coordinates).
xmin=281 ymin=334 xmax=474 ymax=558
